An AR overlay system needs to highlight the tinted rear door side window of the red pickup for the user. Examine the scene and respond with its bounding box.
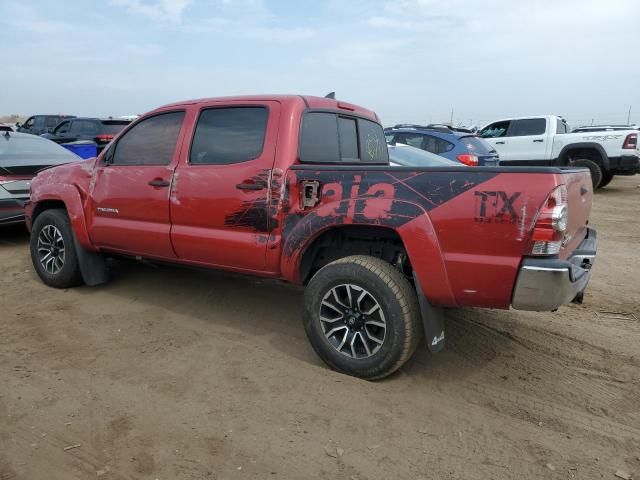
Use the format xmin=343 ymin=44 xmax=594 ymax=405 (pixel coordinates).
xmin=189 ymin=107 xmax=269 ymax=165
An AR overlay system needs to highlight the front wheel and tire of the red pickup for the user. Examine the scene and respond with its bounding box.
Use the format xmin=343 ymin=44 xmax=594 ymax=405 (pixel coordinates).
xmin=30 ymin=209 xmax=82 ymax=288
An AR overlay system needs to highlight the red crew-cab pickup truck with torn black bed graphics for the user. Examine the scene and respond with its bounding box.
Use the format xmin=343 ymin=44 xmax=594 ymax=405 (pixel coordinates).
xmin=26 ymin=95 xmax=596 ymax=379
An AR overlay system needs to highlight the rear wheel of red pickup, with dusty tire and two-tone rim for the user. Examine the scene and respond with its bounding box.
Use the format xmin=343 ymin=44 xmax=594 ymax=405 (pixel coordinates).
xmin=303 ymin=255 xmax=423 ymax=380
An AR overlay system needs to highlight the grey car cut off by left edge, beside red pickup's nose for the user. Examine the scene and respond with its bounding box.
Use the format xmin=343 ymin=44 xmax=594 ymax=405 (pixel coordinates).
xmin=0 ymin=132 xmax=80 ymax=225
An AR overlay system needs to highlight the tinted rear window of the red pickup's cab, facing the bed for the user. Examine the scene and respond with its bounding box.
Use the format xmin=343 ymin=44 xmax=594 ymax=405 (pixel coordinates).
xmin=298 ymin=112 xmax=389 ymax=164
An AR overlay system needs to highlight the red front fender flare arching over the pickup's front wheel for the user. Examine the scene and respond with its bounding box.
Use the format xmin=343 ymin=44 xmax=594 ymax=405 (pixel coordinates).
xmin=27 ymin=183 xmax=96 ymax=251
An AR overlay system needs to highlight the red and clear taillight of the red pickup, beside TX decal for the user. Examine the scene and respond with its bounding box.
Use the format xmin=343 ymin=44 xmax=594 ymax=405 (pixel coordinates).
xmin=530 ymin=185 xmax=569 ymax=255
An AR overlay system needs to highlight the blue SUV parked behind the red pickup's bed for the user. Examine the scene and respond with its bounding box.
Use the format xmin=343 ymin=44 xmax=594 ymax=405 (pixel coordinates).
xmin=384 ymin=124 xmax=500 ymax=167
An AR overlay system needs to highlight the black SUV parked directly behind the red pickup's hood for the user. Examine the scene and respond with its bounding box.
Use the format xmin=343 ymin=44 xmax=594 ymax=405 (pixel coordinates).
xmin=42 ymin=117 xmax=131 ymax=153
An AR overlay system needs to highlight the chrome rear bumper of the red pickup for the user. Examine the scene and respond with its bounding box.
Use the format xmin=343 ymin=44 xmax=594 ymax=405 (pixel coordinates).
xmin=511 ymin=229 xmax=597 ymax=312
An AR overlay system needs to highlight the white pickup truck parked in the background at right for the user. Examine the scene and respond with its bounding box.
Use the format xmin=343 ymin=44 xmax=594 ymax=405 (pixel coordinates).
xmin=479 ymin=115 xmax=640 ymax=189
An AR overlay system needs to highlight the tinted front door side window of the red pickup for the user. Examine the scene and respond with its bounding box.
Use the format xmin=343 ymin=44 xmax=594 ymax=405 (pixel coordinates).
xmin=107 ymin=112 xmax=184 ymax=165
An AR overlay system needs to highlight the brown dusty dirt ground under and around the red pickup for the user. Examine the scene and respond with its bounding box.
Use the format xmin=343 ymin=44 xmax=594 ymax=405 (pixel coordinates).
xmin=0 ymin=177 xmax=640 ymax=480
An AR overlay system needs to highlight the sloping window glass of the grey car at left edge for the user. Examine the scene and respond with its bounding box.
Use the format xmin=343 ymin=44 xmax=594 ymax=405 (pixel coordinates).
xmin=0 ymin=134 xmax=80 ymax=167
